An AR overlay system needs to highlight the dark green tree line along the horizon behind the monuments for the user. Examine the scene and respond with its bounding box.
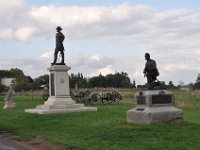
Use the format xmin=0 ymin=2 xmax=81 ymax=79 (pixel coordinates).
xmin=0 ymin=68 xmax=200 ymax=92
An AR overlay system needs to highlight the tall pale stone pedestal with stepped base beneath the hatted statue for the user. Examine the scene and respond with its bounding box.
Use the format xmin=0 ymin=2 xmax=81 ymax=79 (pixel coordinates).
xmin=25 ymin=65 xmax=97 ymax=114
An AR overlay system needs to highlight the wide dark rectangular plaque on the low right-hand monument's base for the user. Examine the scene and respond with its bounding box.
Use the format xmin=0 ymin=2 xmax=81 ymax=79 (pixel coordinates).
xmin=152 ymin=95 xmax=172 ymax=104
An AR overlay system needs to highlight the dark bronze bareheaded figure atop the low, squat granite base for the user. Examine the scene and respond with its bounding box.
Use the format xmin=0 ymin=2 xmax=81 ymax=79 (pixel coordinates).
xmin=143 ymin=53 xmax=159 ymax=85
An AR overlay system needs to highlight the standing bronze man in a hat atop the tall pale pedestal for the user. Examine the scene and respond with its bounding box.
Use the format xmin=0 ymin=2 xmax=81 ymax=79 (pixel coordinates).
xmin=51 ymin=26 xmax=65 ymax=65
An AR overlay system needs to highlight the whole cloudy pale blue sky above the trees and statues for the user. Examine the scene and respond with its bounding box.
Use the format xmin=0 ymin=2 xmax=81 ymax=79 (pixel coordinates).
xmin=0 ymin=0 xmax=200 ymax=84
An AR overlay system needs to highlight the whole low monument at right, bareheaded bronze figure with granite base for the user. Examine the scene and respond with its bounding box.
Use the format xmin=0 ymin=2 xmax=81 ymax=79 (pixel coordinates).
xmin=127 ymin=53 xmax=183 ymax=124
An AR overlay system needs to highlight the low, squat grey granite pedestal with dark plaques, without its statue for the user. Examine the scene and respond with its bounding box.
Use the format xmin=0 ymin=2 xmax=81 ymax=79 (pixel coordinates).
xmin=127 ymin=90 xmax=183 ymax=124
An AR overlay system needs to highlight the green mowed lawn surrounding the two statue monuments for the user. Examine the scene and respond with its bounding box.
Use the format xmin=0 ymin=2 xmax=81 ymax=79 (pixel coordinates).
xmin=0 ymin=92 xmax=200 ymax=150
